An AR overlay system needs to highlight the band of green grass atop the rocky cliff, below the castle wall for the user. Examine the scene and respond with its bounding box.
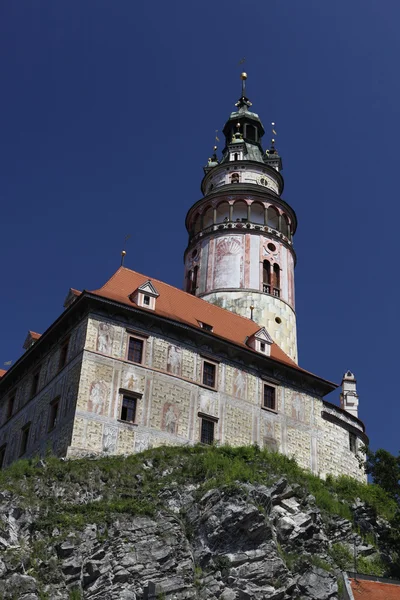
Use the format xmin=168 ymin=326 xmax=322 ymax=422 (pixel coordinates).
xmin=0 ymin=445 xmax=396 ymax=529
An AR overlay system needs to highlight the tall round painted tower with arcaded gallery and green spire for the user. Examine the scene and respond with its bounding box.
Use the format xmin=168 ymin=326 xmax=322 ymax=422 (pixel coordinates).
xmin=185 ymin=73 xmax=297 ymax=362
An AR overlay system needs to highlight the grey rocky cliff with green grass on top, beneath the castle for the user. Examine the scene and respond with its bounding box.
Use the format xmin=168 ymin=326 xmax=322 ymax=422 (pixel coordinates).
xmin=0 ymin=447 xmax=398 ymax=600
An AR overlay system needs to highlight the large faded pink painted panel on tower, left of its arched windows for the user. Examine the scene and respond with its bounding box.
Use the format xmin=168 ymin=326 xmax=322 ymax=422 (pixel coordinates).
xmin=214 ymin=236 xmax=242 ymax=288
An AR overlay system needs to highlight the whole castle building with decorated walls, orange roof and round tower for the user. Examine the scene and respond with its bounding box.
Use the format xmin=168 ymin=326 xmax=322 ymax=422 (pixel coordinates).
xmin=0 ymin=77 xmax=367 ymax=481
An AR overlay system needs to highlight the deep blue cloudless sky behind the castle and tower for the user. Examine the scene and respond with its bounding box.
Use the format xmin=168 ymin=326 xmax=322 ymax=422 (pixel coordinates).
xmin=0 ymin=0 xmax=400 ymax=454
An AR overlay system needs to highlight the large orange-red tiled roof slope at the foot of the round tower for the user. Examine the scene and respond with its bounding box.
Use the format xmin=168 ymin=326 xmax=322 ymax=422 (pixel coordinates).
xmin=91 ymin=267 xmax=334 ymax=385
